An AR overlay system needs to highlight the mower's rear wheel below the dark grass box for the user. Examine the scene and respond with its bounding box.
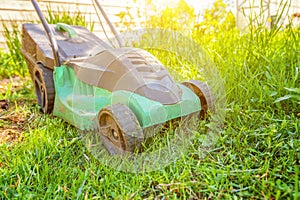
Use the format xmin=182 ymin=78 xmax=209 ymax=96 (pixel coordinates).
xmin=33 ymin=64 xmax=55 ymax=113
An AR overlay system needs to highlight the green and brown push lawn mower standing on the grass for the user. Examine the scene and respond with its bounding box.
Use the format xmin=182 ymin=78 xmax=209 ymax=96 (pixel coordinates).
xmin=21 ymin=0 xmax=214 ymax=154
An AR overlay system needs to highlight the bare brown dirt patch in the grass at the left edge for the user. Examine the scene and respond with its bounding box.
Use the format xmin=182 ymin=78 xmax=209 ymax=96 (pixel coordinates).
xmin=0 ymin=77 xmax=29 ymax=146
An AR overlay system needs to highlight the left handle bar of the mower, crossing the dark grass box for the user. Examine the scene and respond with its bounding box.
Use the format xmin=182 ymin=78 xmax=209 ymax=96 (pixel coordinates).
xmin=31 ymin=0 xmax=61 ymax=67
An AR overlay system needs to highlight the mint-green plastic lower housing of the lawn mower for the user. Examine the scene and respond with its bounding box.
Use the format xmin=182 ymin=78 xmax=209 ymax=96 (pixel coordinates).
xmin=53 ymin=65 xmax=201 ymax=130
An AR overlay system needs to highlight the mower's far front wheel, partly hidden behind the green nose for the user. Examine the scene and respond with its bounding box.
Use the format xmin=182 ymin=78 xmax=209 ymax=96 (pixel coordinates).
xmin=182 ymin=80 xmax=215 ymax=118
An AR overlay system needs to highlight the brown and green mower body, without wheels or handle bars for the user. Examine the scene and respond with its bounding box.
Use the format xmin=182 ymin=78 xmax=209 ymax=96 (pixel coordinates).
xmin=22 ymin=24 xmax=201 ymax=130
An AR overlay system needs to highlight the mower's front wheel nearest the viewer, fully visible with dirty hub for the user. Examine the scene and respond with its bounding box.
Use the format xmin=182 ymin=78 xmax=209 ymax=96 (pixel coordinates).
xmin=98 ymin=104 xmax=144 ymax=155
